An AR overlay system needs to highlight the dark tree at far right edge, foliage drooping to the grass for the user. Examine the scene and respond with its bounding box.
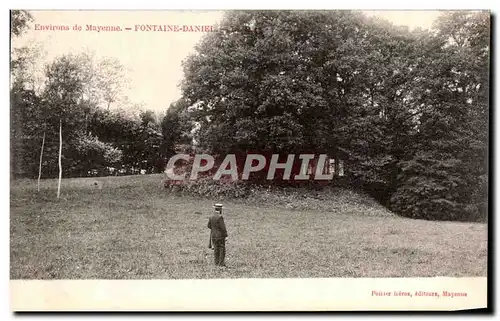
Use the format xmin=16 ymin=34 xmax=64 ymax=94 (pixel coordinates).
xmin=391 ymin=12 xmax=489 ymax=220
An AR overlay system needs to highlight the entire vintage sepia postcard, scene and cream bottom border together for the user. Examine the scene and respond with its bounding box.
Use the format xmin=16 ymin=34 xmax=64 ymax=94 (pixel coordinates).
xmin=9 ymin=9 xmax=491 ymax=310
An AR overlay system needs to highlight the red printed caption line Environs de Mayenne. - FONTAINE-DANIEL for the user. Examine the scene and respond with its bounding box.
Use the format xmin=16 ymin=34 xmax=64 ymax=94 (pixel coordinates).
xmin=35 ymin=24 xmax=217 ymax=32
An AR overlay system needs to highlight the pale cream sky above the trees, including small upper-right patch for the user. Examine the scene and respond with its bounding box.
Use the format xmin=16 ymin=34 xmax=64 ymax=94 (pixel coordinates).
xmin=13 ymin=10 xmax=439 ymax=112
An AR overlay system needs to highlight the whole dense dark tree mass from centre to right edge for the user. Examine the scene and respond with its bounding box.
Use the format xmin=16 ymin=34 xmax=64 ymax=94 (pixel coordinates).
xmin=171 ymin=11 xmax=490 ymax=220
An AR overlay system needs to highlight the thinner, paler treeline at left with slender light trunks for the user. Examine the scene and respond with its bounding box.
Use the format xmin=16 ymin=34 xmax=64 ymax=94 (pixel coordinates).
xmin=10 ymin=10 xmax=166 ymax=178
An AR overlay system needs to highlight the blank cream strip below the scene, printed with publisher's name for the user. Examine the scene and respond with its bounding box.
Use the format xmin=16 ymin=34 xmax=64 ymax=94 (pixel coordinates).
xmin=11 ymin=277 xmax=487 ymax=312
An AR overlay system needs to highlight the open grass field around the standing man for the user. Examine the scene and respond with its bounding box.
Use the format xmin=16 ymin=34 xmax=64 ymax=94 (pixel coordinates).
xmin=10 ymin=175 xmax=487 ymax=279
